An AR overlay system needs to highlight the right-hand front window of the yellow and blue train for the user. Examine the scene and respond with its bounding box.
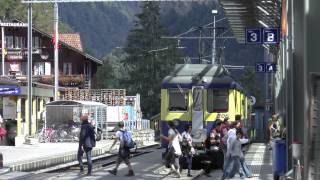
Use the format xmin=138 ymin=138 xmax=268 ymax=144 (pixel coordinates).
xmin=208 ymin=89 xmax=229 ymax=113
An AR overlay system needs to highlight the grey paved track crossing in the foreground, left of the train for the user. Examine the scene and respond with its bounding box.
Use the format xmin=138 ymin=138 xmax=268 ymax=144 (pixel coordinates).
xmin=0 ymin=149 xmax=201 ymax=180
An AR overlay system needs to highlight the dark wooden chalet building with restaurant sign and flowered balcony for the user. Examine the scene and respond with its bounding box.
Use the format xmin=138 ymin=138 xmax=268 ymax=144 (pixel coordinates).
xmin=0 ymin=21 xmax=102 ymax=144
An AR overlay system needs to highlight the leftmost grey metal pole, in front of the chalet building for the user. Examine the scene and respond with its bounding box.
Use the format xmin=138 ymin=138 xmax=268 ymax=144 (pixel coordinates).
xmin=28 ymin=4 xmax=32 ymax=135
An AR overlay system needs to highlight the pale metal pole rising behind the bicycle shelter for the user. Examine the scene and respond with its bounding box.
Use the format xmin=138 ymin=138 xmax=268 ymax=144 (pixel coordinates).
xmin=54 ymin=3 xmax=59 ymax=101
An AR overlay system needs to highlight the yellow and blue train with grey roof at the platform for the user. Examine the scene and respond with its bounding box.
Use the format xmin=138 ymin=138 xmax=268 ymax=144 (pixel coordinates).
xmin=160 ymin=64 xmax=251 ymax=146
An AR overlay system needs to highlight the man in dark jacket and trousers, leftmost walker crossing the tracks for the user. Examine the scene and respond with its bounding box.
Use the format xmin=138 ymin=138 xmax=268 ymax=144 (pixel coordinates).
xmin=78 ymin=115 xmax=96 ymax=176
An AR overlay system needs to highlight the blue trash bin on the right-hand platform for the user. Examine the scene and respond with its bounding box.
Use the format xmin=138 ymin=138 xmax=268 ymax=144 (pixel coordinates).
xmin=272 ymin=139 xmax=287 ymax=179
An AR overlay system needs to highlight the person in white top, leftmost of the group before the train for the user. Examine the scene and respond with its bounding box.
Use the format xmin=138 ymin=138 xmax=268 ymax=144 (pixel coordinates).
xmin=160 ymin=121 xmax=182 ymax=178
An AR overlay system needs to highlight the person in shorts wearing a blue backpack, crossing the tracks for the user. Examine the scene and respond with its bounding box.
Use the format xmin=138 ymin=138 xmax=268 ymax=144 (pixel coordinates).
xmin=108 ymin=121 xmax=134 ymax=176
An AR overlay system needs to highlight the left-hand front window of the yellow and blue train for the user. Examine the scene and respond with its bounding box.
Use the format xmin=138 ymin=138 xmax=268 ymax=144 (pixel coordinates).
xmin=168 ymin=89 xmax=188 ymax=111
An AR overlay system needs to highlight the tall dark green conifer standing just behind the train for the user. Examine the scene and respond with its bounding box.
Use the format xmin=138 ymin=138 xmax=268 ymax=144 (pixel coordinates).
xmin=122 ymin=2 xmax=181 ymax=117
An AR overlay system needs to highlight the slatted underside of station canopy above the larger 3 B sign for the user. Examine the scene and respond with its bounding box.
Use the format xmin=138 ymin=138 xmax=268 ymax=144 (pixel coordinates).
xmin=220 ymin=0 xmax=281 ymax=43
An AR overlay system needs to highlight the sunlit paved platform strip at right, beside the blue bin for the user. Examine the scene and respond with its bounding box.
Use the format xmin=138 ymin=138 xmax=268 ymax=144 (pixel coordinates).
xmin=200 ymin=143 xmax=273 ymax=180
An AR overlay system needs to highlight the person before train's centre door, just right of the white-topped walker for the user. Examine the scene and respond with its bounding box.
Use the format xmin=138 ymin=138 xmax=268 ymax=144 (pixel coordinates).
xmin=182 ymin=125 xmax=195 ymax=177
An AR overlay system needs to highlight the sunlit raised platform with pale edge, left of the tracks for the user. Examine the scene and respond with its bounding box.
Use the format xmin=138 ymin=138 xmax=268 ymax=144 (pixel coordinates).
xmin=0 ymin=140 xmax=157 ymax=173
